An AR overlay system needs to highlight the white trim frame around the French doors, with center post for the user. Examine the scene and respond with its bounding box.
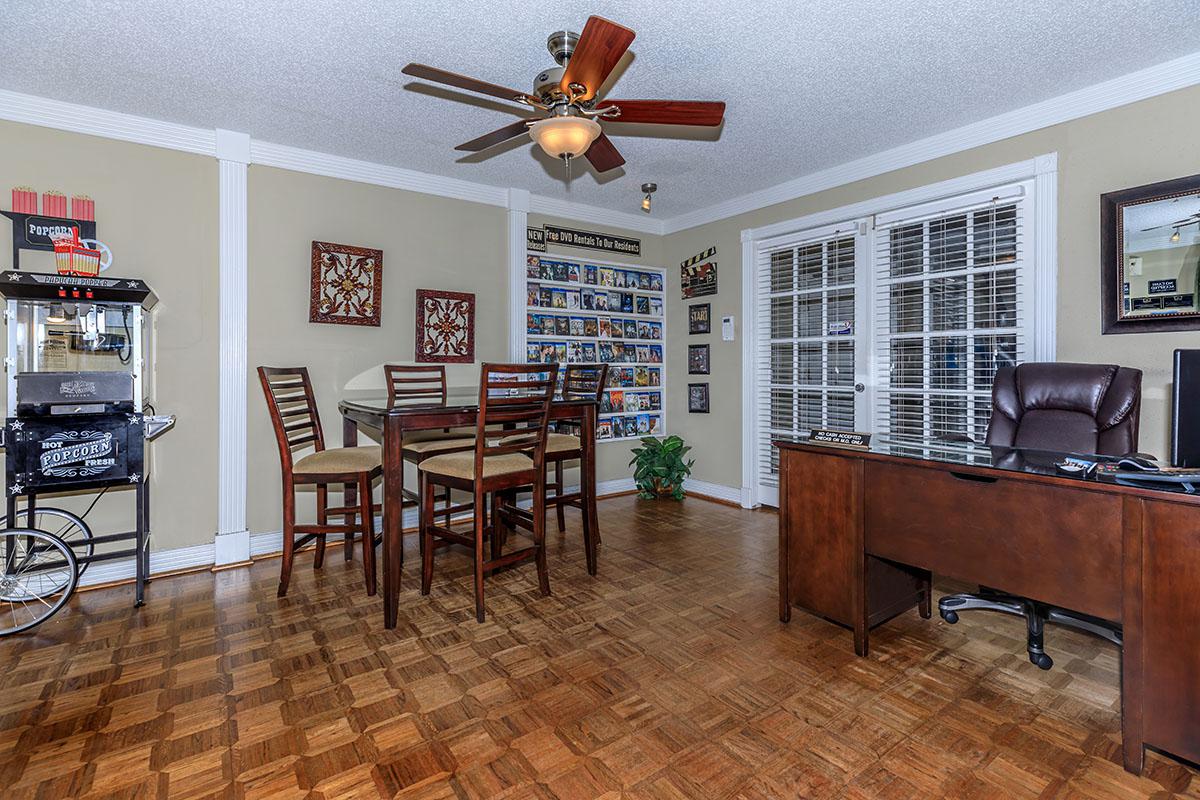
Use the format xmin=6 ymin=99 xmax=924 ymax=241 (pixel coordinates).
xmin=742 ymin=152 xmax=1058 ymax=509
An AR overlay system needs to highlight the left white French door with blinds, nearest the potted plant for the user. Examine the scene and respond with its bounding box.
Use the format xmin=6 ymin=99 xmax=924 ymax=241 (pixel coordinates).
xmin=755 ymin=225 xmax=858 ymax=487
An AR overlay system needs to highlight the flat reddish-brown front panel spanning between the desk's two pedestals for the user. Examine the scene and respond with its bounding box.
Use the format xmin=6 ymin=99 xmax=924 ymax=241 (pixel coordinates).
xmin=864 ymin=462 xmax=1122 ymax=620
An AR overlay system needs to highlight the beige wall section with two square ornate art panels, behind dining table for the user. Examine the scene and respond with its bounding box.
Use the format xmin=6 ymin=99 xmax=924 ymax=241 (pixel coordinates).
xmin=247 ymin=167 xmax=508 ymax=534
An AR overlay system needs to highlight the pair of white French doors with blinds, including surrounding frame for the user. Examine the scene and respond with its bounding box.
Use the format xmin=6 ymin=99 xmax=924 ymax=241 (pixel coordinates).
xmin=743 ymin=167 xmax=1055 ymax=505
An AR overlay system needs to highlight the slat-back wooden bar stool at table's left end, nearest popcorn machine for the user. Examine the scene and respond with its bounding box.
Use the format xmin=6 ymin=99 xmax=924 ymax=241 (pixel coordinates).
xmin=258 ymin=367 xmax=383 ymax=597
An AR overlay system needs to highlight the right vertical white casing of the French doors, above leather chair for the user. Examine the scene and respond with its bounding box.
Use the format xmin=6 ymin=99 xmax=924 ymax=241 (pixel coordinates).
xmin=1033 ymin=152 xmax=1058 ymax=361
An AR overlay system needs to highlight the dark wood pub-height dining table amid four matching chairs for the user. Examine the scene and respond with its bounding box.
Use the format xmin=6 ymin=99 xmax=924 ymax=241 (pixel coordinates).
xmin=337 ymin=386 xmax=600 ymax=628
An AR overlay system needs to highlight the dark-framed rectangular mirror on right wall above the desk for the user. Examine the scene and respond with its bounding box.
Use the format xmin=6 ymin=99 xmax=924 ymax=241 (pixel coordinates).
xmin=1100 ymin=175 xmax=1200 ymax=333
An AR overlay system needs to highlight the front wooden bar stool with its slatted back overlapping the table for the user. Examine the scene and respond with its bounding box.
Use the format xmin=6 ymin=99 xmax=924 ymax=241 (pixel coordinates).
xmin=418 ymin=363 xmax=558 ymax=622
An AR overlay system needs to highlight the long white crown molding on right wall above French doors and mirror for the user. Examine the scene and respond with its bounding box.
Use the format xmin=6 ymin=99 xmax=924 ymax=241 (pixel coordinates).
xmin=664 ymin=53 xmax=1200 ymax=234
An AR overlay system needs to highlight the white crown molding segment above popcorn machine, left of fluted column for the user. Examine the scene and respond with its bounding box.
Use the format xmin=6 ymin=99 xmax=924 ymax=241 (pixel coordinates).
xmin=0 ymin=89 xmax=217 ymax=156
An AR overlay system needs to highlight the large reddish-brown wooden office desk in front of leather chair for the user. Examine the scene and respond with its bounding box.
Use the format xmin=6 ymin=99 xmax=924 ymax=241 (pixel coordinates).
xmin=776 ymin=443 xmax=1200 ymax=774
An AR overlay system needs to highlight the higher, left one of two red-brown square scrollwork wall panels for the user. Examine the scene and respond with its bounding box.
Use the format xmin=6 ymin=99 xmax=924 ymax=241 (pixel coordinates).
xmin=308 ymin=241 xmax=383 ymax=327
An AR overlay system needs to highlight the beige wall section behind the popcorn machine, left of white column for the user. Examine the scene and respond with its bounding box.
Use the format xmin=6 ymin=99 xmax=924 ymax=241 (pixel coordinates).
xmin=0 ymin=122 xmax=218 ymax=551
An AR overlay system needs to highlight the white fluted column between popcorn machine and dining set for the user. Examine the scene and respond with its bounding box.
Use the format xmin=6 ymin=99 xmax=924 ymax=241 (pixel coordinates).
xmin=214 ymin=130 xmax=250 ymax=566
